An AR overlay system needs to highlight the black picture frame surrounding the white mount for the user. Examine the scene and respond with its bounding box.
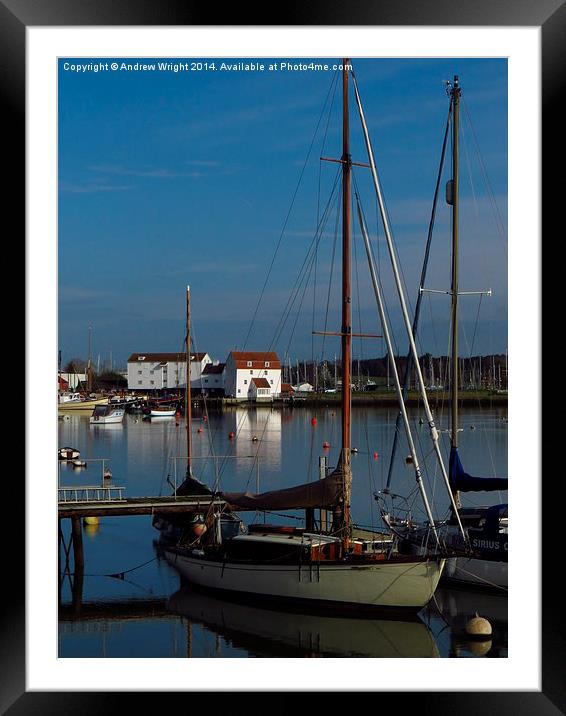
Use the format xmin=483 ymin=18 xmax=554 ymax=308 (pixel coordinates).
xmin=7 ymin=0 xmax=566 ymax=716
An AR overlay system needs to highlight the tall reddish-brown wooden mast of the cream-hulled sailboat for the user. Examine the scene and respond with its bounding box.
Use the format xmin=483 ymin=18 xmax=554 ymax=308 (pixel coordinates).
xmin=340 ymin=58 xmax=352 ymax=526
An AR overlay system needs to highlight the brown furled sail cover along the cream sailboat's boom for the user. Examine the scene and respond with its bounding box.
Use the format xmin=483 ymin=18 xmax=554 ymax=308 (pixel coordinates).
xmin=222 ymin=469 xmax=344 ymax=510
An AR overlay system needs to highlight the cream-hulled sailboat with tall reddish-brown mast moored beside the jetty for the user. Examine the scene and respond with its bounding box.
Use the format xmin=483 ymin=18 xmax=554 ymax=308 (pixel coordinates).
xmin=164 ymin=59 xmax=444 ymax=611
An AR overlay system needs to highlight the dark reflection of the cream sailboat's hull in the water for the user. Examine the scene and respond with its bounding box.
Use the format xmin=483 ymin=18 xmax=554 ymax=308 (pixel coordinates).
xmin=168 ymin=587 xmax=440 ymax=658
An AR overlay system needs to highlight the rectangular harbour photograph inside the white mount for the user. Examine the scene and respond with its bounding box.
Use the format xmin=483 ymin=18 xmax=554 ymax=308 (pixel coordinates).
xmin=56 ymin=53 xmax=510 ymax=663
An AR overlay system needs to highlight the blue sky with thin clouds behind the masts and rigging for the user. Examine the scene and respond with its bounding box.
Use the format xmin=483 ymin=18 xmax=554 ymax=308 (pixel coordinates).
xmin=58 ymin=58 xmax=507 ymax=365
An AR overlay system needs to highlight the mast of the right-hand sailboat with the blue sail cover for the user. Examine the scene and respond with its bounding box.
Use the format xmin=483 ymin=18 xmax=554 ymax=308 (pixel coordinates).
xmin=450 ymin=75 xmax=460 ymax=450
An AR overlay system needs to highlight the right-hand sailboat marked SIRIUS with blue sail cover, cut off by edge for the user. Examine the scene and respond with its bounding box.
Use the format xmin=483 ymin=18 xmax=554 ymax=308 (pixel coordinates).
xmin=376 ymin=76 xmax=508 ymax=588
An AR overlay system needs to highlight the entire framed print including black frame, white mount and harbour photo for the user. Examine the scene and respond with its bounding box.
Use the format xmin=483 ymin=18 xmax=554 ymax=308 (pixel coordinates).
xmin=4 ymin=0 xmax=566 ymax=714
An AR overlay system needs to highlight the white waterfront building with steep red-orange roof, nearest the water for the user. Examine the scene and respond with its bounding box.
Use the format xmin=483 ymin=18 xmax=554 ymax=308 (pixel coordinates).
xmin=224 ymin=351 xmax=281 ymax=401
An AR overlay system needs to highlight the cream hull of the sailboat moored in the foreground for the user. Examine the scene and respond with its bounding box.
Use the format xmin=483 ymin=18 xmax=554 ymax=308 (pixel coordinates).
xmin=165 ymin=548 xmax=444 ymax=610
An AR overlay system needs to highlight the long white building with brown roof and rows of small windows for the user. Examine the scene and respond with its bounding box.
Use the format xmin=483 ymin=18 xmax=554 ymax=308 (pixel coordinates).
xmin=128 ymin=353 xmax=212 ymax=390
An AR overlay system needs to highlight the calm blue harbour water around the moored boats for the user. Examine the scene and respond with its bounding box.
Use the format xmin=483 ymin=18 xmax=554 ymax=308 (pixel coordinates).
xmin=59 ymin=408 xmax=507 ymax=657
